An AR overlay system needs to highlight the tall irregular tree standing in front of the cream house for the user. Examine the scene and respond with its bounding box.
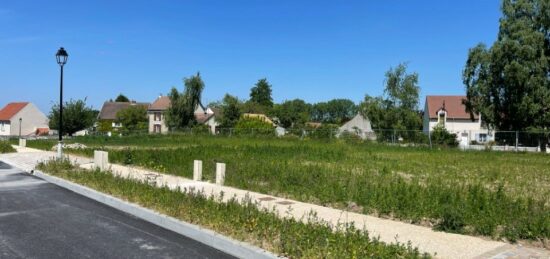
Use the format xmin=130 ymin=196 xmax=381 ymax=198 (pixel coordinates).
xmin=165 ymin=73 xmax=204 ymax=130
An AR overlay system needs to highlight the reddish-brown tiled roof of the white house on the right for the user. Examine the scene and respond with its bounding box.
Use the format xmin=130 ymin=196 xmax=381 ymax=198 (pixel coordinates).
xmin=426 ymin=95 xmax=479 ymax=119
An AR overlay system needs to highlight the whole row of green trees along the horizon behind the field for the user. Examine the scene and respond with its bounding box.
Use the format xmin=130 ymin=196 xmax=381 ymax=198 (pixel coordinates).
xmin=49 ymin=0 xmax=550 ymax=143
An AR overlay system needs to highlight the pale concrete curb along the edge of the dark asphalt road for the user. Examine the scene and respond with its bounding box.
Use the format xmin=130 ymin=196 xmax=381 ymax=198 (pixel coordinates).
xmin=34 ymin=170 xmax=280 ymax=259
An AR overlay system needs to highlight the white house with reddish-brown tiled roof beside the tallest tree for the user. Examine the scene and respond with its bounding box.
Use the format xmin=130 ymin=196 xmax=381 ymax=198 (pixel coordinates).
xmin=423 ymin=95 xmax=493 ymax=146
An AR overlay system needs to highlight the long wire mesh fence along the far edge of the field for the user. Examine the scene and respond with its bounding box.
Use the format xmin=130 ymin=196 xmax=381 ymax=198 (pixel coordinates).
xmin=5 ymin=127 xmax=550 ymax=152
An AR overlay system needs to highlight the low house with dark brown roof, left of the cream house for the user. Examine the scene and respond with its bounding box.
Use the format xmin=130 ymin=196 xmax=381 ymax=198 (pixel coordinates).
xmin=96 ymin=101 xmax=149 ymax=136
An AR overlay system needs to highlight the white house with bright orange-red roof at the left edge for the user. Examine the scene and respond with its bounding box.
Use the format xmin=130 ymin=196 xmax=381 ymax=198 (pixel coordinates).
xmin=0 ymin=102 xmax=49 ymax=136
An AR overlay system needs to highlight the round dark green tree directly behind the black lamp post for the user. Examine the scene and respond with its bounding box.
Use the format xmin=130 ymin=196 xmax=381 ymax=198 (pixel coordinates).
xmin=48 ymin=99 xmax=98 ymax=136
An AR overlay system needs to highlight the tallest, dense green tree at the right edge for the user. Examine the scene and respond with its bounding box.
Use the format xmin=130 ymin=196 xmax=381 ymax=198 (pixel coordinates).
xmin=463 ymin=0 xmax=550 ymax=130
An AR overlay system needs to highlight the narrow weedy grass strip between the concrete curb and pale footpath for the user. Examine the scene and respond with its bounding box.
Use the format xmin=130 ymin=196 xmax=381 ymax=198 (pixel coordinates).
xmin=39 ymin=161 xmax=430 ymax=258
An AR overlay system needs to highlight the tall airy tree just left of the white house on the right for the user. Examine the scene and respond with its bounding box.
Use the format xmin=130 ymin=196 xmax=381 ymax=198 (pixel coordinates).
xmin=361 ymin=64 xmax=422 ymax=141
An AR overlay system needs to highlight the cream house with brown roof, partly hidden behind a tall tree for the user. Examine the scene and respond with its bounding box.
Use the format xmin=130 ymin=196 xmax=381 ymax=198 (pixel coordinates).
xmin=147 ymin=96 xmax=219 ymax=134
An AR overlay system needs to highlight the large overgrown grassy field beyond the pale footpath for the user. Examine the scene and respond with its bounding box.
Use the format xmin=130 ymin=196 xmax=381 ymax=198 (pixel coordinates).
xmin=23 ymin=135 xmax=550 ymax=242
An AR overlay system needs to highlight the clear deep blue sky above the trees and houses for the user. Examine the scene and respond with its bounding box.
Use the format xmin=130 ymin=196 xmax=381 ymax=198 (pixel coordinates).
xmin=0 ymin=0 xmax=500 ymax=112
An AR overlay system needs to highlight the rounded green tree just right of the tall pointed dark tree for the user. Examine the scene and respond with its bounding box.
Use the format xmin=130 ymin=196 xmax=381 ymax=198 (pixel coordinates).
xmin=273 ymin=99 xmax=311 ymax=128
